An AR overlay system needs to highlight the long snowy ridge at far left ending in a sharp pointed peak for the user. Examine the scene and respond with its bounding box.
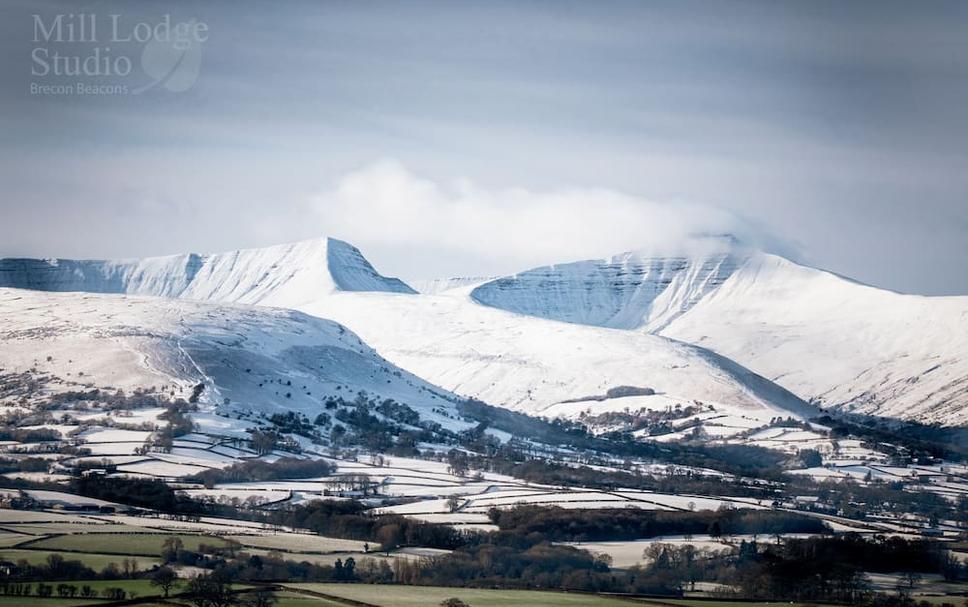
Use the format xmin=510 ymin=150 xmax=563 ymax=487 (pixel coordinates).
xmin=0 ymin=238 xmax=414 ymax=307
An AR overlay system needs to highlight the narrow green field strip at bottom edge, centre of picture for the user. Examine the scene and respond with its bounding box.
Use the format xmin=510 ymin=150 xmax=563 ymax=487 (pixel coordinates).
xmin=286 ymin=584 xmax=644 ymax=607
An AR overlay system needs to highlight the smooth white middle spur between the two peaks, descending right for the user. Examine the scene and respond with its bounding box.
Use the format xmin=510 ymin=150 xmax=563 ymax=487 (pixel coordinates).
xmin=302 ymin=288 xmax=813 ymax=420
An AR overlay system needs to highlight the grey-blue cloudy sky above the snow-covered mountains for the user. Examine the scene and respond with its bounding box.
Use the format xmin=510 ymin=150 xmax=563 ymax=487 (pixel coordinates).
xmin=0 ymin=0 xmax=968 ymax=295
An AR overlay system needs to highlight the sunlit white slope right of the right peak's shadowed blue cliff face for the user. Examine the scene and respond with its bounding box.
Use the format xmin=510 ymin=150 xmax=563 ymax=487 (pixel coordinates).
xmin=661 ymin=254 xmax=968 ymax=424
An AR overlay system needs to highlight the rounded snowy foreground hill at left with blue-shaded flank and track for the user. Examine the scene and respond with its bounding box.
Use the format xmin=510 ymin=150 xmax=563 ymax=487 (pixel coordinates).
xmin=0 ymin=289 xmax=454 ymax=425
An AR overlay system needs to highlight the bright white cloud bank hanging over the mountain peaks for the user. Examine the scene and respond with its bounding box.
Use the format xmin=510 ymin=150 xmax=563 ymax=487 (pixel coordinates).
xmin=312 ymin=160 xmax=772 ymax=276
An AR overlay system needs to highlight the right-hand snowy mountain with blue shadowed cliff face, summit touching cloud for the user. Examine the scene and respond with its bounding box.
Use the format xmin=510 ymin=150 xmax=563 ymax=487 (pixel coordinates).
xmin=472 ymin=239 xmax=968 ymax=424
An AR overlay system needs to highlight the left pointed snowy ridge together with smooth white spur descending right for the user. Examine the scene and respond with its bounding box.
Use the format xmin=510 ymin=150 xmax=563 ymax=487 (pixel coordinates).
xmin=0 ymin=239 xmax=811 ymax=425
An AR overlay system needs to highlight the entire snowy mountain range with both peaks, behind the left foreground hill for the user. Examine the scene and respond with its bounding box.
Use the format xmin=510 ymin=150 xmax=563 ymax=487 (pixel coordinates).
xmin=0 ymin=237 xmax=968 ymax=424
